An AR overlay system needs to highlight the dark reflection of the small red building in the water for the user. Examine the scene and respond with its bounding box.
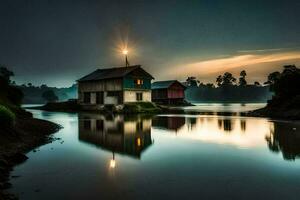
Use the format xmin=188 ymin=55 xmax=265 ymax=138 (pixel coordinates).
xmin=152 ymin=116 xmax=185 ymax=132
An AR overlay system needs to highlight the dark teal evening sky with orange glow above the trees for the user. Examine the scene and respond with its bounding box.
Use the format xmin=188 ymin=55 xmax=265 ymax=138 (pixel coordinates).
xmin=0 ymin=0 xmax=300 ymax=87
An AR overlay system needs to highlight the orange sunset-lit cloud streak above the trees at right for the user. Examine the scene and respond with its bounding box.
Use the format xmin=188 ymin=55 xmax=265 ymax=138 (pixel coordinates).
xmin=162 ymin=52 xmax=300 ymax=83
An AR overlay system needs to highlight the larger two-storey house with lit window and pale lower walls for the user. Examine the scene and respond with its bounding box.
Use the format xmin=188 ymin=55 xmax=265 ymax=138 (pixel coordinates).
xmin=77 ymin=65 xmax=154 ymax=109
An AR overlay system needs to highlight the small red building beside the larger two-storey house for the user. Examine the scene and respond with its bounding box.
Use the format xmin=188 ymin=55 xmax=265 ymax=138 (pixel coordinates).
xmin=151 ymin=80 xmax=186 ymax=104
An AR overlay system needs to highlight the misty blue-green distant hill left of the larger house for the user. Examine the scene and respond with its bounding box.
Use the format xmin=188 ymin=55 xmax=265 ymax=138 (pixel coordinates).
xmin=17 ymin=84 xmax=77 ymax=104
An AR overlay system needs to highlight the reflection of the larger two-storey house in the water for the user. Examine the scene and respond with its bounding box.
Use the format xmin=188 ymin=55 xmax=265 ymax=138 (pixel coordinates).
xmin=78 ymin=113 xmax=152 ymax=159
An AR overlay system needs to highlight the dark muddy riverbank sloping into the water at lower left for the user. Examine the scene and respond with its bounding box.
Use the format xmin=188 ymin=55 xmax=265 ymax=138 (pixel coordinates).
xmin=0 ymin=116 xmax=60 ymax=200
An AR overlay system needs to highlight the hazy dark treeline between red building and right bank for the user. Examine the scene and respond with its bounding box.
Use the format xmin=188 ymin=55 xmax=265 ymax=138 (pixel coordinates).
xmin=185 ymin=70 xmax=272 ymax=103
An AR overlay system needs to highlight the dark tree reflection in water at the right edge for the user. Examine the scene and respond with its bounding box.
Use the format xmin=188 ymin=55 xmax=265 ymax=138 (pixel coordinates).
xmin=266 ymin=122 xmax=300 ymax=160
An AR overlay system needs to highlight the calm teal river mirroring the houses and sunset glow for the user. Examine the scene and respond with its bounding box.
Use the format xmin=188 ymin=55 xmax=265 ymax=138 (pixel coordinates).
xmin=11 ymin=104 xmax=300 ymax=200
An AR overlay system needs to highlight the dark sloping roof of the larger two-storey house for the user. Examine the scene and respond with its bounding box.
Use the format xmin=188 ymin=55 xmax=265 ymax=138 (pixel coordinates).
xmin=77 ymin=65 xmax=154 ymax=82
